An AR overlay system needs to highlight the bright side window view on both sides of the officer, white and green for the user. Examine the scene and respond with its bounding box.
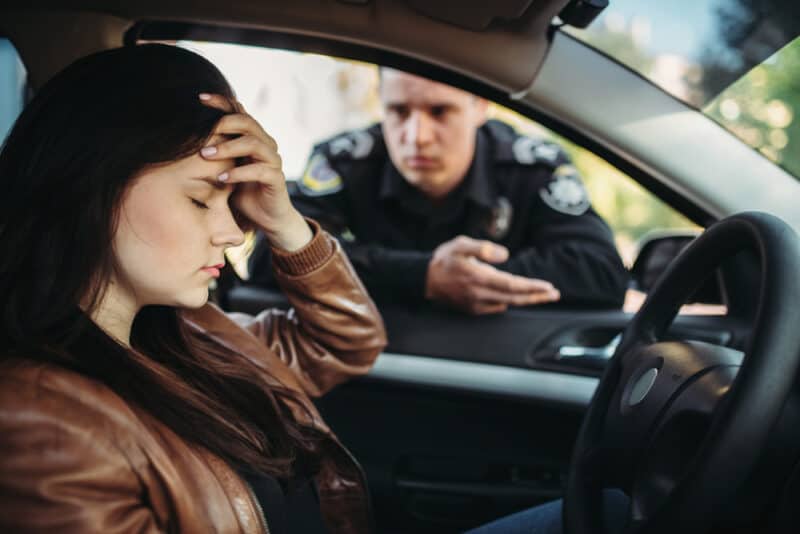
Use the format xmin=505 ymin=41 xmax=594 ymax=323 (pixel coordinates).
xmin=178 ymin=41 xmax=712 ymax=309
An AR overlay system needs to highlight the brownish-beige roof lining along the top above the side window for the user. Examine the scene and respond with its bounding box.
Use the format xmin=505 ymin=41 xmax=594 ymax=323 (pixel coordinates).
xmin=6 ymin=0 xmax=568 ymax=91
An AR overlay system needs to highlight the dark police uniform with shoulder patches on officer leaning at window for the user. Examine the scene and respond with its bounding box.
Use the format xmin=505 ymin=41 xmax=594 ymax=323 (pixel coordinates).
xmin=250 ymin=120 xmax=628 ymax=306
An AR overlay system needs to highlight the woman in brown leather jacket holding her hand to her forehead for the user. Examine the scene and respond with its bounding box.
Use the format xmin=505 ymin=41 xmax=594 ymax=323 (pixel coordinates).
xmin=0 ymin=45 xmax=385 ymax=533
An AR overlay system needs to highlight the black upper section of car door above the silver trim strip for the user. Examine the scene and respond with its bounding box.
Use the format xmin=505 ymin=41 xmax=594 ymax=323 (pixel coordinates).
xmin=223 ymin=286 xmax=748 ymax=376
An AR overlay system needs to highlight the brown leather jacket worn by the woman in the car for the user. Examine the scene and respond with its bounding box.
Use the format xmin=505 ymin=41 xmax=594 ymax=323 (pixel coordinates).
xmin=0 ymin=225 xmax=386 ymax=533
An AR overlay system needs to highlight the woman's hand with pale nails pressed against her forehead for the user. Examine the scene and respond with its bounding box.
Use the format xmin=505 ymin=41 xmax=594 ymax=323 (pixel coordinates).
xmin=200 ymin=94 xmax=313 ymax=251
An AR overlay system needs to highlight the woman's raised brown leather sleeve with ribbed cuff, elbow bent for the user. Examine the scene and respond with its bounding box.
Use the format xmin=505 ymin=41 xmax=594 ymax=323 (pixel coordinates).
xmin=229 ymin=220 xmax=386 ymax=397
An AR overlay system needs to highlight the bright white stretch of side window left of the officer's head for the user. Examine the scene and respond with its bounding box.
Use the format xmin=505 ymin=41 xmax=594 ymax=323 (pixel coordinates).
xmin=179 ymin=41 xmax=380 ymax=180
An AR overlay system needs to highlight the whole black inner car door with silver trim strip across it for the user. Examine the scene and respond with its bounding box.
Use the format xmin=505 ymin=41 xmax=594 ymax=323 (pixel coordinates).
xmin=224 ymin=286 xmax=746 ymax=533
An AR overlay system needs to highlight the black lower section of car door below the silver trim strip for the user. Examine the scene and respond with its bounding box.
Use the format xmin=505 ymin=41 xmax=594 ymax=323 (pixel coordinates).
xmin=317 ymin=376 xmax=582 ymax=533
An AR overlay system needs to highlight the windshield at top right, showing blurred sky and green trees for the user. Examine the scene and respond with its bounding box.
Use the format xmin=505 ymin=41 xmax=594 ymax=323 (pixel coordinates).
xmin=564 ymin=0 xmax=800 ymax=178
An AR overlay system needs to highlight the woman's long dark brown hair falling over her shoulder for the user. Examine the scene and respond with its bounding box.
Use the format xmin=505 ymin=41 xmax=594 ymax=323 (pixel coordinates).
xmin=0 ymin=44 xmax=319 ymax=476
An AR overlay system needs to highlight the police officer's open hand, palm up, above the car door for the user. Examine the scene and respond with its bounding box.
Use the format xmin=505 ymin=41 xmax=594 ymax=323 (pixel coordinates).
xmin=425 ymin=236 xmax=561 ymax=315
